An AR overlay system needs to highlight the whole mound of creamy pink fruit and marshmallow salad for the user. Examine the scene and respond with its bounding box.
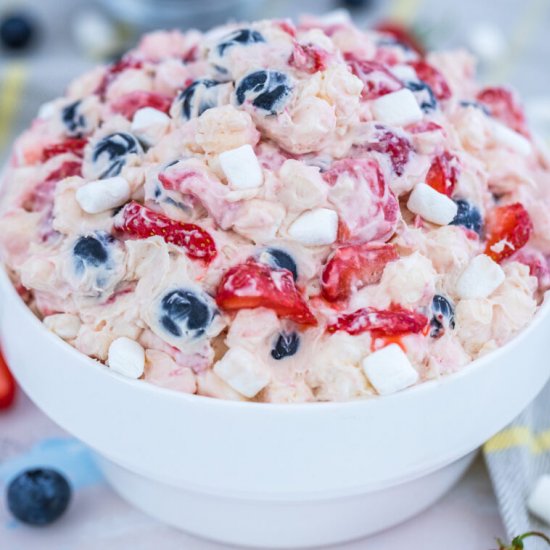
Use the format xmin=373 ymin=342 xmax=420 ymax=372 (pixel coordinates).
xmin=0 ymin=19 xmax=550 ymax=402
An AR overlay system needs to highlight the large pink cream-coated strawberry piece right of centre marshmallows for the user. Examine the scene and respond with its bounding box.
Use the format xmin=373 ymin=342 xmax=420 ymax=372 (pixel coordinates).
xmin=323 ymin=158 xmax=400 ymax=242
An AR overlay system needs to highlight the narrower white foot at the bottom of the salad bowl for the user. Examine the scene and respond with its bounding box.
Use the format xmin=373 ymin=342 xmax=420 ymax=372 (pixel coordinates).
xmin=96 ymin=452 xmax=475 ymax=548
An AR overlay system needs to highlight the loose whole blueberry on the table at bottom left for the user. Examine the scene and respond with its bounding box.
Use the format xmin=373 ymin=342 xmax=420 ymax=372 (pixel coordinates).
xmin=7 ymin=468 xmax=71 ymax=525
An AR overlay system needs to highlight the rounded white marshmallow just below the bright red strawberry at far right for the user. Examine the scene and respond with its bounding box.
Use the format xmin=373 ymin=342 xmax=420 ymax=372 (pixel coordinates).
xmin=456 ymin=254 xmax=506 ymax=300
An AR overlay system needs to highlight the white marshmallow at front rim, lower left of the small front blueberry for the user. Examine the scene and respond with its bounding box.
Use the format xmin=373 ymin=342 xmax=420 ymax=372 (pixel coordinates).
xmin=214 ymin=347 xmax=270 ymax=398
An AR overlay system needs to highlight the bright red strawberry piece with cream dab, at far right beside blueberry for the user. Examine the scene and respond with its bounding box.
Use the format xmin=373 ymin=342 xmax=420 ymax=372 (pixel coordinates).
xmin=485 ymin=202 xmax=533 ymax=262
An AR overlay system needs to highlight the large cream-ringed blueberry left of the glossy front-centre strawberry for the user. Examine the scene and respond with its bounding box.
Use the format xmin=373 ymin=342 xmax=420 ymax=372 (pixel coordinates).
xmin=160 ymin=289 xmax=214 ymax=338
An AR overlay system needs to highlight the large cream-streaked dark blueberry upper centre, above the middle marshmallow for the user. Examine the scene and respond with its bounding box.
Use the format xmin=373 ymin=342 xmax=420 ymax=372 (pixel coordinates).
xmin=235 ymin=71 xmax=292 ymax=115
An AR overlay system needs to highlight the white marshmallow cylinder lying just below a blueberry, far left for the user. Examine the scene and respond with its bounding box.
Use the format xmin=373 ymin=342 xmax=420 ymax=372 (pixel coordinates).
xmin=76 ymin=176 xmax=131 ymax=214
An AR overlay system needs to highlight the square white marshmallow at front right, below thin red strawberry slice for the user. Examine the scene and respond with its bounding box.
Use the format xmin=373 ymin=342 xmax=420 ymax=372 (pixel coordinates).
xmin=362 ymin=344 xmax=418 ymax=395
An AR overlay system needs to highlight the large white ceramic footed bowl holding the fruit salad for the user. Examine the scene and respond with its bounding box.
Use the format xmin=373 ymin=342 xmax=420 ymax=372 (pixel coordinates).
xmin=0 ymin=271 xmax=550 ymax=548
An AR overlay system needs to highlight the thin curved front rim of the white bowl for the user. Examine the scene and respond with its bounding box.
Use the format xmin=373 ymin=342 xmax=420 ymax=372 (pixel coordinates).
xmin=0 ymin=262 xmax=550 ymax=413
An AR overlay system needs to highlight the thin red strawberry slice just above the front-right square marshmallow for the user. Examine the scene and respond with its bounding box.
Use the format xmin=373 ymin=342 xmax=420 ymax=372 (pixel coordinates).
xmin=327 ymin=306 xmax=428 ymax=338
